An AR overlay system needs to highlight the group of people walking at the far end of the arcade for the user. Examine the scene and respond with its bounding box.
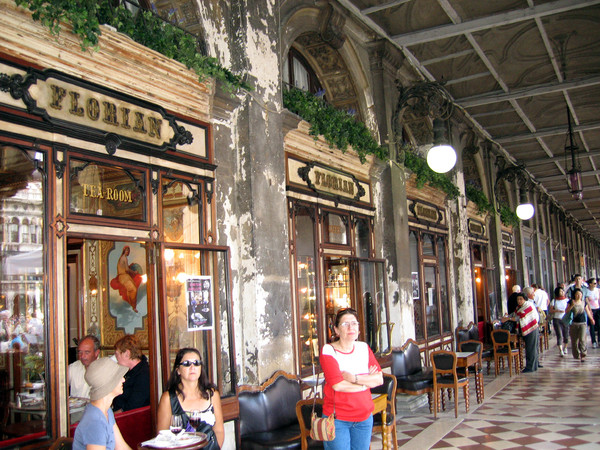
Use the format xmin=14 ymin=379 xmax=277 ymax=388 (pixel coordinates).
xmin=502 ymin=274 xmax=600 ymax=373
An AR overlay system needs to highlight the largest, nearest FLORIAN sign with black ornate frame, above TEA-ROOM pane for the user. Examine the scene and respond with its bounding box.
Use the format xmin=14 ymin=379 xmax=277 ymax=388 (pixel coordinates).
xmin=0 ymin=66 xmax=194 ymax=154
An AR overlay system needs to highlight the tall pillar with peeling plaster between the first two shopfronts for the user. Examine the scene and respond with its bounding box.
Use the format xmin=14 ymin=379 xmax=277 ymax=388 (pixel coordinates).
xmin=199 ymin=0 xmax=294 ymax=384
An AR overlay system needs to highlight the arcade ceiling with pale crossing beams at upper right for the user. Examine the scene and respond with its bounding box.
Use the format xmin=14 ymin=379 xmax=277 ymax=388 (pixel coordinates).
xmin=338 ymin=0 xmax=600 ymax=240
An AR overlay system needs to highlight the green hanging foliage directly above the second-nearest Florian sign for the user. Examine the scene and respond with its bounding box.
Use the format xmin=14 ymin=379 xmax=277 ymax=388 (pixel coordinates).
xmin=283 ymin=88 xmax=388 ymax=163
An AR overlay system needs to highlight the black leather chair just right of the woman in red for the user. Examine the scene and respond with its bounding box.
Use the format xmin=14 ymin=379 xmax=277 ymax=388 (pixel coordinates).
xmin=391 ymin=339 xmax=433 ymax=411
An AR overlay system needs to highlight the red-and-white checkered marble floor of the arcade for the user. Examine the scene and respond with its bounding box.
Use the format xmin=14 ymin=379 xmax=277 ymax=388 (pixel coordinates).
xmin=371 ymin=335 xmax=600 ymax=450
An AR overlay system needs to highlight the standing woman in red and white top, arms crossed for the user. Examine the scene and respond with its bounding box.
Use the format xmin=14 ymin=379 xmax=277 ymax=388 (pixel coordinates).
xmin=321 ymin=308 xmax=383 ymax=450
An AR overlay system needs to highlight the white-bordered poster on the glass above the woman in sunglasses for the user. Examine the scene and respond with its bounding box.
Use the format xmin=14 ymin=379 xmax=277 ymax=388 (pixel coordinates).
xmin=185 ymin=276 xmax=213 ymax=331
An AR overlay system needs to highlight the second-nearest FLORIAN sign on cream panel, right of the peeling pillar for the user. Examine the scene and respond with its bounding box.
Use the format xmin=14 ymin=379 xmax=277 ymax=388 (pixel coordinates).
xmin=288 ymin=158 xmax=370 ymax=202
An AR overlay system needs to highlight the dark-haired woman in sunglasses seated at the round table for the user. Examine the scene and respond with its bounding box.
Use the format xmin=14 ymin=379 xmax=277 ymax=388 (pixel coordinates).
xmin=157 ymin=348 xmax=225 ymax=450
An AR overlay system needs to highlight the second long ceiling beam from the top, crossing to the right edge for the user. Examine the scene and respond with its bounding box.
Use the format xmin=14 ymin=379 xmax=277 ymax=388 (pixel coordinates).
xmin=455 ymin=76 xmax=600 ymax=108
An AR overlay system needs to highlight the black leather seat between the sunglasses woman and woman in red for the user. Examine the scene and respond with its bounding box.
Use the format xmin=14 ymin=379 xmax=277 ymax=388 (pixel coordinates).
xmin=238 ymin=371 xmax=302 ymax=450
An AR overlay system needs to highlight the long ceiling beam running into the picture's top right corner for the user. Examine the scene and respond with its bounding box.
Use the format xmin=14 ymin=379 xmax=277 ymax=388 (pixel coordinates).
xmin=392 ymin=0 xmax=600 ymax=47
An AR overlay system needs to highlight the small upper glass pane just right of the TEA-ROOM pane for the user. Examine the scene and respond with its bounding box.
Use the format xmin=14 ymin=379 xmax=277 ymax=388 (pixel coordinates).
xmin=162 ymin=179 xmax=201 ymax=244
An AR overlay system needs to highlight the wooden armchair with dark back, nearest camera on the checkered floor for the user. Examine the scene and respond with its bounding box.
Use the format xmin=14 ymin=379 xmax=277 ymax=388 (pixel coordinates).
xmin=431 ymin=350 xmax=469 ymax=418
